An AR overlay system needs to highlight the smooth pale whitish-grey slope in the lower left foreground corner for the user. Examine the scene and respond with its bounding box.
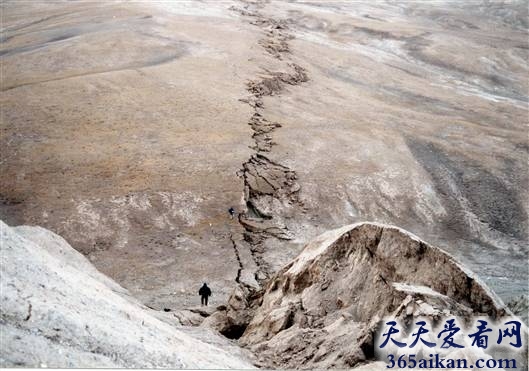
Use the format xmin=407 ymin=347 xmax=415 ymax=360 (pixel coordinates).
xmin=0 ymin=221 xmax=252 ymax=369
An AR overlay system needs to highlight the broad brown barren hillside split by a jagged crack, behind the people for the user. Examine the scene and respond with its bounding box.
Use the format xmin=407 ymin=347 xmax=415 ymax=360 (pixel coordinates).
xmin=0 ymin=1 xmax=529 ymax=309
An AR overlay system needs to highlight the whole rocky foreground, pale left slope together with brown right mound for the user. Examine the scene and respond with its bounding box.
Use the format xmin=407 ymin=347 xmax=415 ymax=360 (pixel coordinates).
xmin=0 ymin=222 xmax=527 ymax=370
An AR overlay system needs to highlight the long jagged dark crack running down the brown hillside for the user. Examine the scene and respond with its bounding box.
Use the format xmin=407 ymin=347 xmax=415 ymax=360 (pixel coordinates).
xmin=230 ymin=1 xmax=308 ymax=282
